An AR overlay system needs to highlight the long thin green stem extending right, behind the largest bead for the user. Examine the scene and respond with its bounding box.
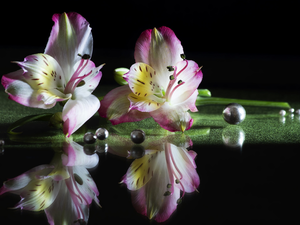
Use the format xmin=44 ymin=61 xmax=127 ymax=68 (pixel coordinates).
xmin=196 ymin=96 xmax=291 ymax=108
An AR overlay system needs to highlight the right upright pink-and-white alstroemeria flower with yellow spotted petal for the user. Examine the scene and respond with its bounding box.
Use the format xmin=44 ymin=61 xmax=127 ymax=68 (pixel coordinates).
xmin=99 ymin=27 xmax=202 ymax=132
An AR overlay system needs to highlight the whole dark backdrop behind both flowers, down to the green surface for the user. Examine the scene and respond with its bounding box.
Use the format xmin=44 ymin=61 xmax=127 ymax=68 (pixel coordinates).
xmin=0 ymin=0 xmax=300 ymax=88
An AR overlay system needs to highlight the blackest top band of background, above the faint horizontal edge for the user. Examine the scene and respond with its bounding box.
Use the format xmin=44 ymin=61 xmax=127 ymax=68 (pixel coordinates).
xmin=1 ymin=0 xmax=300 ymax=55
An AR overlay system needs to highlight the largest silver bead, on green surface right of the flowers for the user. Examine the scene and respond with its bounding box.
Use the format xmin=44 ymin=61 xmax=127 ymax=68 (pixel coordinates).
xmin=223 ymin=103 xmax=246 ymax=124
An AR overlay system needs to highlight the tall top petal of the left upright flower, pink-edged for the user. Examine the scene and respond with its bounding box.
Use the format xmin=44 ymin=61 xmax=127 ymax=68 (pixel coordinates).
xmin=45 ymin=12 xmax=93 ymax=80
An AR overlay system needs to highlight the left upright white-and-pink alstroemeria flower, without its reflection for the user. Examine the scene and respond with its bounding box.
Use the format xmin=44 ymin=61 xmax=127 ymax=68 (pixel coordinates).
xmin=1 ymin=13 xmax=103 ymax=137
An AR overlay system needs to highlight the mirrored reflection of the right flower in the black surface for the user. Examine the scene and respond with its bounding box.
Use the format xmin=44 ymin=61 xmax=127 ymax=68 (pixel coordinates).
xmin=122 ymin=142 xmax=200 ymax=222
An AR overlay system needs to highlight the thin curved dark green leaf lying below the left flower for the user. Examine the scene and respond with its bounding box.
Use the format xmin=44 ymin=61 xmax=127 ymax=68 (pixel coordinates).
xmin=7 ymin=113 xmax=53 ymax=134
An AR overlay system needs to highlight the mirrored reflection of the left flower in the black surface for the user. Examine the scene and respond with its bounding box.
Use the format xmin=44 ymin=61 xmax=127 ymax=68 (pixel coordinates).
xmin=0 ymin=142 xmax=99 ymax=224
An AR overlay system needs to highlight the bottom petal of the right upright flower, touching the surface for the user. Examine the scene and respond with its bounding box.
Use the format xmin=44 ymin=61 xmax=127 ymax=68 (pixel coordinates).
xmin=150 ymin=103 xmax=193 ymax=132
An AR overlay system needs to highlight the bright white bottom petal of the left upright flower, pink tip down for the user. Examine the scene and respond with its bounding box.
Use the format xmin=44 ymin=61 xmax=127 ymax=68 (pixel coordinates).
xmin=62 ymin=95 xmax=100 ymax=137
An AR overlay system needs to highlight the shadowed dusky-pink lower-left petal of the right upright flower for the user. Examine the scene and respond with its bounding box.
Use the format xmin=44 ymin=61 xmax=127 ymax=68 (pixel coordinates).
xmin=98 ymin=85 xmax=150 ymax=125
